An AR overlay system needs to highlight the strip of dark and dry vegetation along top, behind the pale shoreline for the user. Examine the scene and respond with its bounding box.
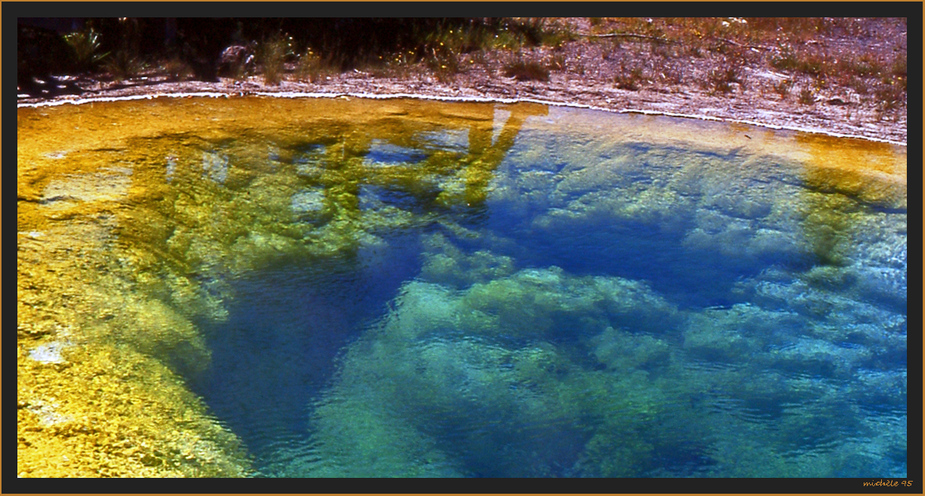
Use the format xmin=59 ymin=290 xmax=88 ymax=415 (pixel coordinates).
xmin=18 ymin=17 xmax=907 ymax=120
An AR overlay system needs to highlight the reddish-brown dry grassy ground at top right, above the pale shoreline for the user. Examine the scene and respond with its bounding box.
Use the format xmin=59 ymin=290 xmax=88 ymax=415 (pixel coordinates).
xmin=572 ymin=17 xmax=907 ymax=116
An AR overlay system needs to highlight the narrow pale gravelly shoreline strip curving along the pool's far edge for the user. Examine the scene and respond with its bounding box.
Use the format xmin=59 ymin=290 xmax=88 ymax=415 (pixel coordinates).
xmin=19 ymin=75 xmax=907 ymax=145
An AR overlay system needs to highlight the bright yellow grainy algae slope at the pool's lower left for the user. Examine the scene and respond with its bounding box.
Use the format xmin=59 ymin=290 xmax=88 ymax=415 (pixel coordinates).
xmin=17 ymin=204 xmax=249 ymax=477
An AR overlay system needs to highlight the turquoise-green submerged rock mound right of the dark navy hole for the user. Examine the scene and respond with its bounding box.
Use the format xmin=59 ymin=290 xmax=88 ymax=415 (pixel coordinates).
xmin=302 ymin=244 xmax=673 ymax=477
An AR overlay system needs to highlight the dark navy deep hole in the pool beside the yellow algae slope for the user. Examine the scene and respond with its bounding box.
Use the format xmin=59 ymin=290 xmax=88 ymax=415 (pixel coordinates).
xmin=190 ymin=236 xmax=420 ymax=463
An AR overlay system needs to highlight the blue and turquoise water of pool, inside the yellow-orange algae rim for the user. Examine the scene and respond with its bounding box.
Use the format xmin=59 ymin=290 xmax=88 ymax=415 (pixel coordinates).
xmin=170 ymin=106 xmax=906 ymax=477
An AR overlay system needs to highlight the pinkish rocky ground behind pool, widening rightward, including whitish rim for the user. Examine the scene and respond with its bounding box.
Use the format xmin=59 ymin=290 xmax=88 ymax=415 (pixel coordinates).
xmin=19 ymin=18 xmax=907 ymax=144
